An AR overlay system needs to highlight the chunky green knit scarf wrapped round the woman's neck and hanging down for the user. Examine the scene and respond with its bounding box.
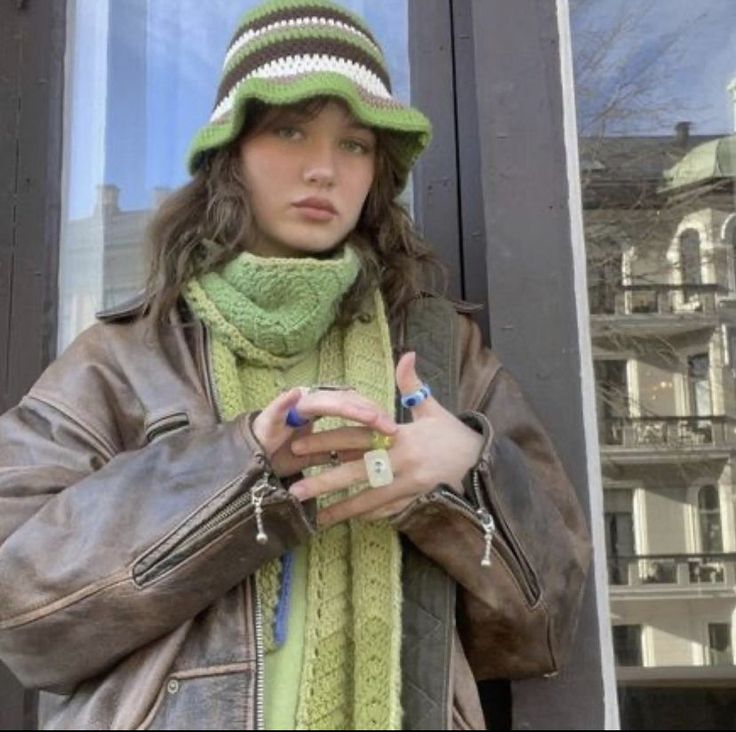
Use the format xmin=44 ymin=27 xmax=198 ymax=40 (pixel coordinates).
xmin=184 ymin=244 xmax=401 ymax=730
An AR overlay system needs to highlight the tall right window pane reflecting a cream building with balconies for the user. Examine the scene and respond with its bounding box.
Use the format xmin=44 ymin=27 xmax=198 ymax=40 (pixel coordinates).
xmin=570 ymin=0 xmax=736 ymax=729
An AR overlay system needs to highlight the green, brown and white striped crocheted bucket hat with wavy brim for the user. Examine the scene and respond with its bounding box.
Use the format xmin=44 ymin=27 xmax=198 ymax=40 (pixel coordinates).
xmin=187 ymin=0 xmax=432 ymax=189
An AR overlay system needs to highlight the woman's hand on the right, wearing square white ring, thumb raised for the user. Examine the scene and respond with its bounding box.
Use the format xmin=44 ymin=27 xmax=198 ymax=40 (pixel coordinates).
xmin=289 ymin=352 xmax=483 ymax=527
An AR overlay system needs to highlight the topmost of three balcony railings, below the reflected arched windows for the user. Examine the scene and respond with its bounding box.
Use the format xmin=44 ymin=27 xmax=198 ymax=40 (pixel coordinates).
xmin=589 ymin=283 xmax=726 ymax=315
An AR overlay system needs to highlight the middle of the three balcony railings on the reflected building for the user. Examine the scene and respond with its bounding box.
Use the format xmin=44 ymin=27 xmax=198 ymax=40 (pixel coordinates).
xmin=601 ymin=415 xmax=736 ymax=448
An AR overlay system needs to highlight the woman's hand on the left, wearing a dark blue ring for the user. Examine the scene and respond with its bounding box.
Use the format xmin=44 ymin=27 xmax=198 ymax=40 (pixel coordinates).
xmin=252 ymin=387 xmax=398 ymax=478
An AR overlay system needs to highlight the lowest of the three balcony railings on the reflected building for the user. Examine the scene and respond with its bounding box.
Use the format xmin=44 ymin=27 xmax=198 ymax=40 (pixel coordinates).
xmin=608 ymin=553 xmax=736 ymax=587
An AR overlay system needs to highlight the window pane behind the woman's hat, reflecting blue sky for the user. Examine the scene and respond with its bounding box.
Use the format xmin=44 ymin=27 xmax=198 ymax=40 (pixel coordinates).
xmin=58 ymin=0 xmax=412 ymax=352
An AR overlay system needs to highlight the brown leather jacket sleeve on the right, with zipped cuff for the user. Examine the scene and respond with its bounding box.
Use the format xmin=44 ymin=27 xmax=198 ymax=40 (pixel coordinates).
xmin=394 ymin=315 xmax=592 ymax=680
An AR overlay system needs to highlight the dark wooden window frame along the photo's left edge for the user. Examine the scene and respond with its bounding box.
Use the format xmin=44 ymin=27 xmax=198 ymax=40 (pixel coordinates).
xmin=0 ymin=0 xmax=67 ymax=729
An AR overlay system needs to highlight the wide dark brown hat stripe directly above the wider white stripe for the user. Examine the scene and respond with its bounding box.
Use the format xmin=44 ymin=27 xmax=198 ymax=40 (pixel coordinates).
xmin=214 ymin=37 xmax=392 ymax=109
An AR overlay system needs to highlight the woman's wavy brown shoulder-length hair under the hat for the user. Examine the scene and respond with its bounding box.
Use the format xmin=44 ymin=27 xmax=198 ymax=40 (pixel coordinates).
xmin=145 ymin=96 xmax=447 ymax=324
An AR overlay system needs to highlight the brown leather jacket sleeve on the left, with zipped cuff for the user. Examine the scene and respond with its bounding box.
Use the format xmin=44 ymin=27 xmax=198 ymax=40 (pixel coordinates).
xmin=0 ymin=334 xmax=314 ymax=693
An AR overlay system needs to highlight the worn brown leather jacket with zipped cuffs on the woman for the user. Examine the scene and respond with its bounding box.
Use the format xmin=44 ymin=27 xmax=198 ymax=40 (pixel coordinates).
xmin=0 ymin=292 xmax=591 ymax=730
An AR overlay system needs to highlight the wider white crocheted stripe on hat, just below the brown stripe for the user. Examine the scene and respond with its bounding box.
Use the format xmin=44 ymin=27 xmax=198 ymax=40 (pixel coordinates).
xmin=210 ymin=55 xmax=392 ymax=123
